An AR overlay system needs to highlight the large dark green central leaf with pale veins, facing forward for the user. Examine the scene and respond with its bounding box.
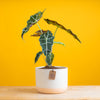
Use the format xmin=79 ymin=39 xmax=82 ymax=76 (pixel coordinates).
xmin=39 ymin=30 xmax=54 ymax=56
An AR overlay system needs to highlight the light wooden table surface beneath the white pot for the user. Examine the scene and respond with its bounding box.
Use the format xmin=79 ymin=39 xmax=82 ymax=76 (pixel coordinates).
xmin=0 ymin=86 xmax=100 ymax=100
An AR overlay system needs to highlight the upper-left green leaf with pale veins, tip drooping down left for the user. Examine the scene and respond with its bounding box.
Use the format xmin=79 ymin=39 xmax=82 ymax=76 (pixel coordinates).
xmin=21 ymin=11 xmax=44 ymax=39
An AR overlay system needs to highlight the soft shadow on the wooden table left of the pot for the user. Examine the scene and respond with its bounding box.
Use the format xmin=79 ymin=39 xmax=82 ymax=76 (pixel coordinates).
xmin=14 ymin=88 xmax=38 ymax=94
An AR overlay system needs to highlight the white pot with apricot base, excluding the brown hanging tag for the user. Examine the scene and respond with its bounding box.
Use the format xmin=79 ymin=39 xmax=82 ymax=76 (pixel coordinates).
xmin=36 ymin=66 xmax=68 ymax=93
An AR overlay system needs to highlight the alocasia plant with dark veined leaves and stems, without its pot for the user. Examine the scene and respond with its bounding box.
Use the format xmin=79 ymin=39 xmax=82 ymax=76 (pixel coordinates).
xmin=21 ymin=10 xmax=81 ymax=67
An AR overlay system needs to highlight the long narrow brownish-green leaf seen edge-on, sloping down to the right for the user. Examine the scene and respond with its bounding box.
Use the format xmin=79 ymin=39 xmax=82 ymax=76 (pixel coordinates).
xmin=44 ymin=19 xmax=81 ymax=43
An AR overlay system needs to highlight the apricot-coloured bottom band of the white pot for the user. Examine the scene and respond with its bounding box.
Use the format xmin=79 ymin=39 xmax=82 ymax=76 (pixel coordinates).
xmin=36 ymin=88 xmax=66 ymax=94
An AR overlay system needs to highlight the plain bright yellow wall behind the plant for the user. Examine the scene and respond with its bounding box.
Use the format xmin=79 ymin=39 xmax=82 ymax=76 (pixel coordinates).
xmin=0 ymin=0 xmax=100 ymax=86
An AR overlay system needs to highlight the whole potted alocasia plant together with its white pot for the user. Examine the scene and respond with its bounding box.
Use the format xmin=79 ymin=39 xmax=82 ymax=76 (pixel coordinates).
xmin=21 ymin=11 xmax=81 ymax=93
